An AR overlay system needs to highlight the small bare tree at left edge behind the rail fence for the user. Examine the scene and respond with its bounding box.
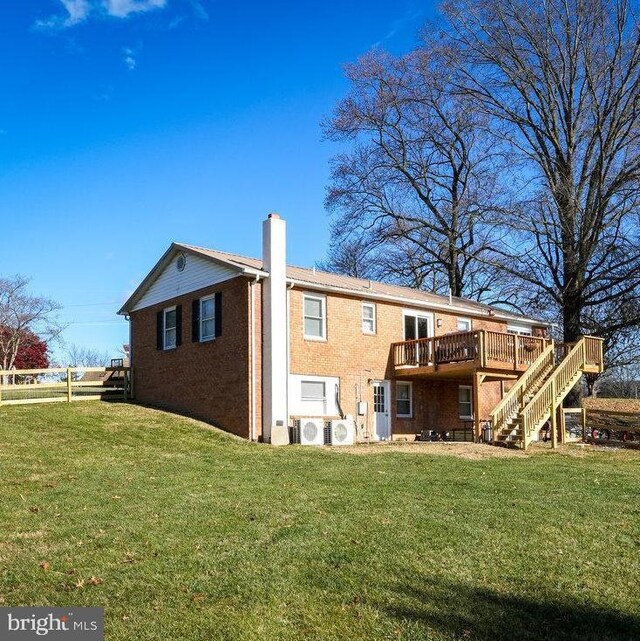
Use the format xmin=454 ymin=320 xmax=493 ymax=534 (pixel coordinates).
xmin=0 ymin=276 xmax=64 ymax=370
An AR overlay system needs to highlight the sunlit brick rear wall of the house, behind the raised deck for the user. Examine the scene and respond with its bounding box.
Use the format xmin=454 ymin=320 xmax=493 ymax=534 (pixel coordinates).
xmin=290 ymin=289 xmax=506 ymax=439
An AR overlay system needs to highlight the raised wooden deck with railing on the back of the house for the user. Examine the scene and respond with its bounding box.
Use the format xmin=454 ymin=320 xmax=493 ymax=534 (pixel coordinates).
xmin=391 ymin=329 xmax=550 ymax=379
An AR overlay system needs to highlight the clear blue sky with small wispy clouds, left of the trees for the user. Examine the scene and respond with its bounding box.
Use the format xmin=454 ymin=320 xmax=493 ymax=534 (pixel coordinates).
xmin=0 ymin=0 xmax=433 ymax=358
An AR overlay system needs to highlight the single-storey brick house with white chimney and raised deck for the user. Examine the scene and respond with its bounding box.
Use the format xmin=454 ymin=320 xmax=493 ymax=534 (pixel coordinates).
xmin=119 ymin=214 xmax=604 ymax=443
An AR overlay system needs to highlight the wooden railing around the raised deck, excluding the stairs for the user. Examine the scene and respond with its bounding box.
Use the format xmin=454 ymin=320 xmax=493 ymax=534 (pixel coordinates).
xmin=392 ymin=329 xmax=547 ymax=369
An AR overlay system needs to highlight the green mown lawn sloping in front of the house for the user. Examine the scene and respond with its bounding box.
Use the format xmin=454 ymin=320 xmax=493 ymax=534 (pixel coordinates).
xmin=0 ymin=402 xmax=640 ymax=641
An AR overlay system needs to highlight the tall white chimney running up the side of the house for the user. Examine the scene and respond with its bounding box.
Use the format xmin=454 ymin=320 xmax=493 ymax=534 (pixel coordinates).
xmin=262 ymin=214 xmax=289 ymax=445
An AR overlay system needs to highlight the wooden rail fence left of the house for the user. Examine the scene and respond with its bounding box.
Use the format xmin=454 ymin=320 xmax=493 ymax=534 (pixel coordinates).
xmin=0 ymin=365 xmax=133 ymax=405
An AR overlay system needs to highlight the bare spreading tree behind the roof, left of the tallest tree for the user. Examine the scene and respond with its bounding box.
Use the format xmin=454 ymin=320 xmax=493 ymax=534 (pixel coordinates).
xmin=325 ymin=42 xmax=510 ymax=298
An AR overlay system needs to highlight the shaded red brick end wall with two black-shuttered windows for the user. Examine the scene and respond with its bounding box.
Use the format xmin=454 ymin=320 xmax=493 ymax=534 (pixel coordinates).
xmin=131 ymin=277 xmax=250 ymax=438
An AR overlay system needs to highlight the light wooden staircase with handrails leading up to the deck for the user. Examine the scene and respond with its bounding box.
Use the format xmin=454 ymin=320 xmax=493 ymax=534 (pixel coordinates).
xmin=491 ymin=336 xmax=603 ymax=450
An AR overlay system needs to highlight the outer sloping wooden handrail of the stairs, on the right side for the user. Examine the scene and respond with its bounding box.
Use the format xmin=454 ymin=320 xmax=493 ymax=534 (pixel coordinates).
xmin=520 ymin=337 xmax=585 ymax=448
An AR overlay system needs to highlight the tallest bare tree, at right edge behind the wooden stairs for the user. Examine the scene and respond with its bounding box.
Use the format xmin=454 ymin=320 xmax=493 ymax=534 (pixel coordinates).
xmin=445 ymin=0 xmax=640 ymax=350
